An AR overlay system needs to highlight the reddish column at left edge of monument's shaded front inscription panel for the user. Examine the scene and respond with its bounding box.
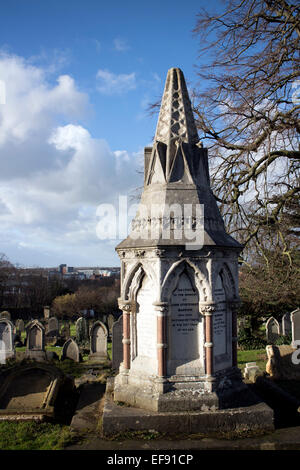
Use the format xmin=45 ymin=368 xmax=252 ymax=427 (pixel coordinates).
xmin=153 ymin=302 xmax=168 ymax=378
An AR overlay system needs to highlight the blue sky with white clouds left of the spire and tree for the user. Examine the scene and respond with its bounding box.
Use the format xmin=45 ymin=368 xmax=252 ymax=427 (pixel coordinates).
xmin=0 ymin=0 xmax=216 ymax=266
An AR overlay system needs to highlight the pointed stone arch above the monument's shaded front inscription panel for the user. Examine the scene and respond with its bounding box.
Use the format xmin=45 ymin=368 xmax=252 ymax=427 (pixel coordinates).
xmin=161 ymin=259 xmax=211 ymax=302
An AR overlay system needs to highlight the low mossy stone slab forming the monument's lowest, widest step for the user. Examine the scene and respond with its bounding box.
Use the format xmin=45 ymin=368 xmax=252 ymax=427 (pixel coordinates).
xmin=102 ymin=380 xmax=274 ymax=436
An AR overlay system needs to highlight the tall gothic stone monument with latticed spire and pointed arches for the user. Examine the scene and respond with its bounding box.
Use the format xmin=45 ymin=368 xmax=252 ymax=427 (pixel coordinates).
xmin=103 ymin=68 xmax=272 ymax=432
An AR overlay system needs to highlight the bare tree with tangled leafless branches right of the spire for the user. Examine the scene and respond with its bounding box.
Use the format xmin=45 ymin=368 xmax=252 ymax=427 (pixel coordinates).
xmin=194 ymin=0 xmax=300 ymax=260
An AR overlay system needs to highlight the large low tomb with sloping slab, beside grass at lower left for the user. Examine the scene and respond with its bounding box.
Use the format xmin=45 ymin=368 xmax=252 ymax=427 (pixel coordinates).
xmin=0 ymin=363 xmax=74 ymax=421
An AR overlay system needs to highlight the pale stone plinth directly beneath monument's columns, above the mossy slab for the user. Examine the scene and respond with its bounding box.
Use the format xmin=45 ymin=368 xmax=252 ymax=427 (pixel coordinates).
xmin=114 ymin=368 xmax=247 ymax=412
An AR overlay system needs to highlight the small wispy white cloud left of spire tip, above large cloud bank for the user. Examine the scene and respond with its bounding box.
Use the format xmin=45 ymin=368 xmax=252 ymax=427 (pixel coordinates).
xmin=97 ymin=69 xmax=136 ymax=95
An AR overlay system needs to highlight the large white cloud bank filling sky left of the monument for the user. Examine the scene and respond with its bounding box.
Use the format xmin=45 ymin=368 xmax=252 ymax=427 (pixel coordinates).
xmin=0 ymin=55 xmax=139 ymax=265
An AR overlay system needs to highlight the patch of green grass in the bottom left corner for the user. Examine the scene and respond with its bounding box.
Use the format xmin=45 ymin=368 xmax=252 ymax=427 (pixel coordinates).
xmin=0 ymin=421 xmax=78 ymax=450
